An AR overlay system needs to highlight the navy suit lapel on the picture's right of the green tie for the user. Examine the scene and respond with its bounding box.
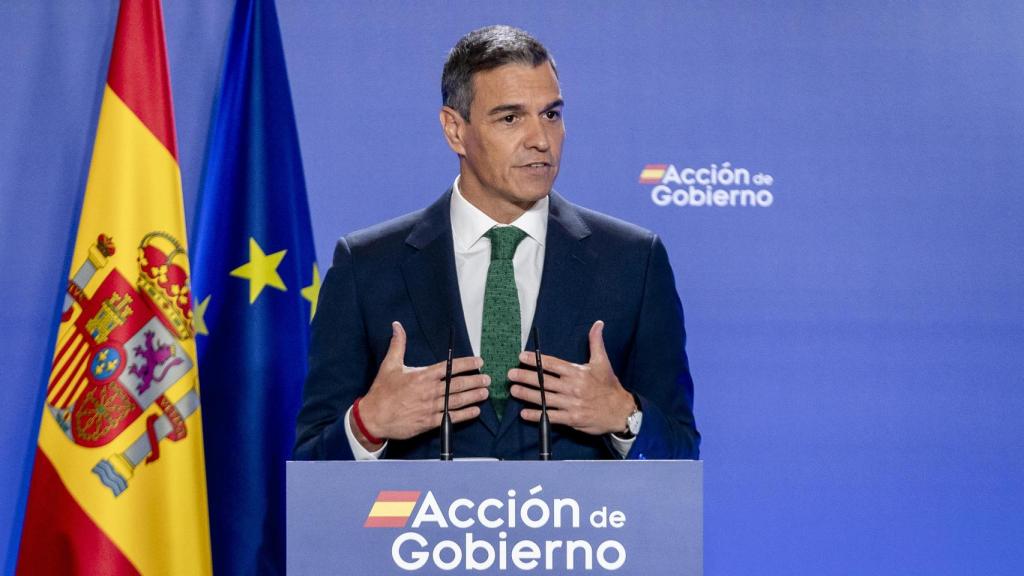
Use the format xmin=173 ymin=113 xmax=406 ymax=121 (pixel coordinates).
xmin=498 ymin=191 xmax=597 ymax=437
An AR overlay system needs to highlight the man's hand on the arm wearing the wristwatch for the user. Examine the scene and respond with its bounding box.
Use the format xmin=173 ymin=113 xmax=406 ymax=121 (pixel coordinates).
xmin=509 ymin=321 xmax=634 ymax=435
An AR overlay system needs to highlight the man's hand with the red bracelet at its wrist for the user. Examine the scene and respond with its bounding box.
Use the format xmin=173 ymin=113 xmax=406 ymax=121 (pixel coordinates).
xmin=351 ymin=322 xmax=490 ymax=451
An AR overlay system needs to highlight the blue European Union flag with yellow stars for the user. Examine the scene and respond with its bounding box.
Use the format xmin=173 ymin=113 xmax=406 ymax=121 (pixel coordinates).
xmin=191 ymin=0 xmax=319 ymax=574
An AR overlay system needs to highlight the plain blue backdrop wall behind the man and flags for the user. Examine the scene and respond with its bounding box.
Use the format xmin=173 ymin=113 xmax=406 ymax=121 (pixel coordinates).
xmin=0 ymin=0 xmax=1024 ymax=575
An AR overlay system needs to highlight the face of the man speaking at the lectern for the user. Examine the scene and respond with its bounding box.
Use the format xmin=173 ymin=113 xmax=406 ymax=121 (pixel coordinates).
xmin=442 ymin=63 xmax=565 ymax=221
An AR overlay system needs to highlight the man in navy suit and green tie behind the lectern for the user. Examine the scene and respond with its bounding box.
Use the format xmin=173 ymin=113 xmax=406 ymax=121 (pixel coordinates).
xmin=295 ymin=26 xmax=700 ymax=459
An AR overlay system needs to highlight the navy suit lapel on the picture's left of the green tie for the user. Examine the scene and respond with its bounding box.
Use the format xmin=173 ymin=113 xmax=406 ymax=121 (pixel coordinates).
xmin=401 ymin=190 xmax=498 ymax=434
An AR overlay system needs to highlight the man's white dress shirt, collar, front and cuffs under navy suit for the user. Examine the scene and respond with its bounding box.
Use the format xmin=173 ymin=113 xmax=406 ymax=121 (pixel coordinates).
xmin=345 ymin=177 xmax=635 ymax=460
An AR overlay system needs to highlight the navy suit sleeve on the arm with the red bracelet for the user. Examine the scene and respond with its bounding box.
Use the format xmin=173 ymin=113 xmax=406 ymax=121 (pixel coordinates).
xmin=294 ymin=239 xmax=373 ymax=460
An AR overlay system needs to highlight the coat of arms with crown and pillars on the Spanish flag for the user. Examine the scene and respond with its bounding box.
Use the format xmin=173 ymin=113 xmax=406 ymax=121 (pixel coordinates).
xmin=46 ymin=232 xmax=199 ymax=496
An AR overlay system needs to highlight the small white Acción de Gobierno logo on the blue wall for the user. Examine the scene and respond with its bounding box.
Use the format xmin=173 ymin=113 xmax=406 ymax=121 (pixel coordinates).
xmin=640 ymin=162 xmax=775 ymax=208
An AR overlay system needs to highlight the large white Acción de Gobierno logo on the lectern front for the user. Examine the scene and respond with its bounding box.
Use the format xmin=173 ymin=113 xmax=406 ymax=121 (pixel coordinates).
xmin=362 ymin=485 xmax=626 ymax=574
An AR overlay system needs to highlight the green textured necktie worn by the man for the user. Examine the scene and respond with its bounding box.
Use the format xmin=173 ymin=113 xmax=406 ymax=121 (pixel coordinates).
xmin=480 ymin=227 xmax=526 ymax=420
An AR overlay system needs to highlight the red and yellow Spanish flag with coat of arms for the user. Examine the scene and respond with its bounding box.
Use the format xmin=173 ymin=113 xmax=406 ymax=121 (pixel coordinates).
xmin=17 ymin=0 xmax=211 ymax=575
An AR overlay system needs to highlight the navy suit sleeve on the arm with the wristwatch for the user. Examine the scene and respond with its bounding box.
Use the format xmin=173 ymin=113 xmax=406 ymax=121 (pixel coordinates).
xmin=623 ymin=236 xmax=700 ymax=460
